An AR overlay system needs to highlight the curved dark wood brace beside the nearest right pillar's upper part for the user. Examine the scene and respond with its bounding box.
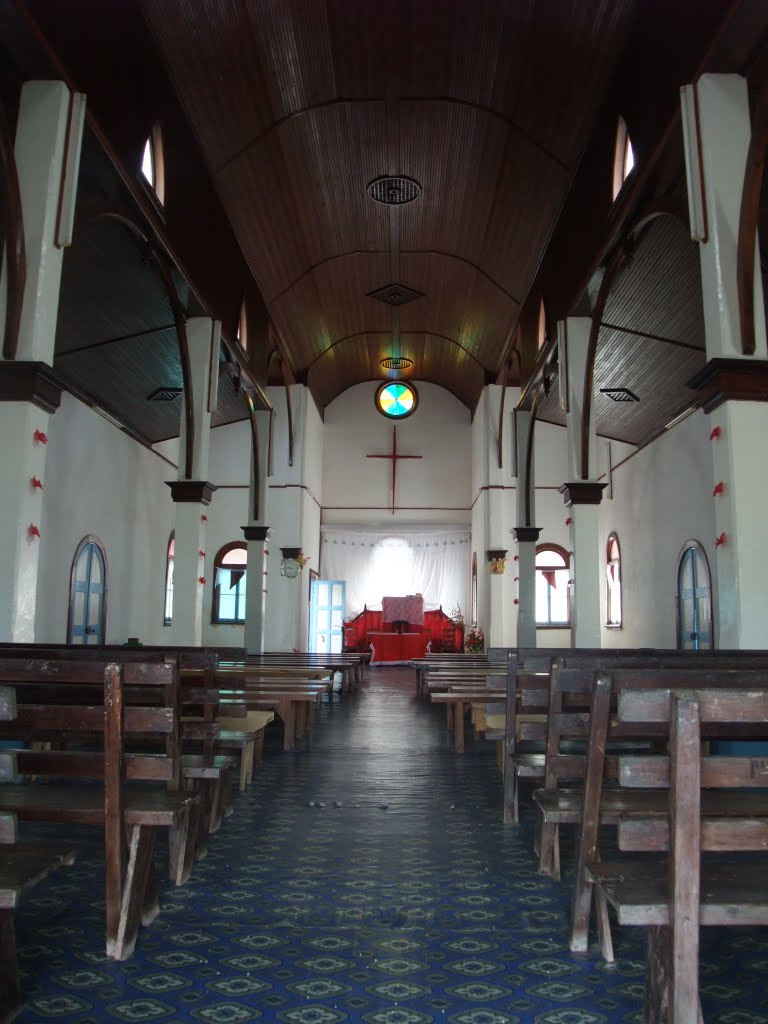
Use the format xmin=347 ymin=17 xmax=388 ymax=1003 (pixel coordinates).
xmin=736 ymin=89 xmax=768 ymax=355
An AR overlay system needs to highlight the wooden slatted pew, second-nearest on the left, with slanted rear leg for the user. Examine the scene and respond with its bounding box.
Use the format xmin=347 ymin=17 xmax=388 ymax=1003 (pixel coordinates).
xmin=0 ymin=658 xmax=199 ymax=959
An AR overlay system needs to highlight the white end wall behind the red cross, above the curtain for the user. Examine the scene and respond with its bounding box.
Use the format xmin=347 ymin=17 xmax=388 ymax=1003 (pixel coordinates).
xmin=323 ymin=381 xmax=472 ymax=525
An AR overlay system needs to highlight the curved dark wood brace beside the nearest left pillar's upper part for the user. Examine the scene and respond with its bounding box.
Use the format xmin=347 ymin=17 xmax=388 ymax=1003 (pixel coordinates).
xmin=0 ymin=96 xmax=27 ymax=359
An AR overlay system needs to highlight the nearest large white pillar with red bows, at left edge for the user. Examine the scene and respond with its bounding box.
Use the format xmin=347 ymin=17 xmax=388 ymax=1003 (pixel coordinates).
xmin=0 ymin=82 xmax=80 ymax=642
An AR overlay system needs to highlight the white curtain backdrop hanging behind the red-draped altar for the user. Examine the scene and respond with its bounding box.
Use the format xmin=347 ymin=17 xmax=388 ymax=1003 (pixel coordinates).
xmin=321 ymin=527 xmax=470 ymax=617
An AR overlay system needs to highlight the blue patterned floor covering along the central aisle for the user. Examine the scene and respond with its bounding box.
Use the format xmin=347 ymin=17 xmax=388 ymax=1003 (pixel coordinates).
xmin=9 ymin=670 xmax=768 ymax=1024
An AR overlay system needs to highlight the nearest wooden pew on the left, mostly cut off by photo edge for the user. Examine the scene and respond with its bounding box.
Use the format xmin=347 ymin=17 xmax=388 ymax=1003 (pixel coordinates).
xmin=0 ymin=687 xmax=75 ymax=1024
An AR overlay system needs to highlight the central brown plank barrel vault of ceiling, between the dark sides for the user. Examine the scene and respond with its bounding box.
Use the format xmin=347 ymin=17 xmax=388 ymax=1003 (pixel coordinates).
xmin=143 ymin=0 xmax=633 ymax=407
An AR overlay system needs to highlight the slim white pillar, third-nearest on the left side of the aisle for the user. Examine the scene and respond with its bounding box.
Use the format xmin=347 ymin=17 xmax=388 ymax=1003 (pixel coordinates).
xmin=243 ymin=411 xmax=272 ymax=654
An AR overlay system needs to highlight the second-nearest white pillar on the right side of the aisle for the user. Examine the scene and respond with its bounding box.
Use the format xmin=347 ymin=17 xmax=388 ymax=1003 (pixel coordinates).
xmin=559 ymin=316 xmax=606 ymax=647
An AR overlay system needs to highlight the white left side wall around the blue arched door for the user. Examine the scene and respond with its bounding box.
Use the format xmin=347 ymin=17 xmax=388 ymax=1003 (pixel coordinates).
xmin=36 ymin=392 xmax=176 ymax=643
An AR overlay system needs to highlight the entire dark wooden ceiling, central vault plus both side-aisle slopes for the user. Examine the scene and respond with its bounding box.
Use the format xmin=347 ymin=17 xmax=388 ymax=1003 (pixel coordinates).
xmin=0 ymin=0 xmax=768 ymax=443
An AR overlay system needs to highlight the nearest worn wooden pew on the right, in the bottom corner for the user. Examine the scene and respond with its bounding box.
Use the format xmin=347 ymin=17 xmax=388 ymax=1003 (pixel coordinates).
xmin=588 ymin=687 xmax=768 ymax=1024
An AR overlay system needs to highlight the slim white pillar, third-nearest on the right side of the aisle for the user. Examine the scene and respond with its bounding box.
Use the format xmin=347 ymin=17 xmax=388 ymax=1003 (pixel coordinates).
xmin=513 ymin=410 xmax=541 ymax=647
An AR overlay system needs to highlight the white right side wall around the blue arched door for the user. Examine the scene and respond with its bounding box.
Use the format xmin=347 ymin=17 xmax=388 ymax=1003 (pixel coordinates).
xmin=600 ymin=412 xmax=718 ymax=647
